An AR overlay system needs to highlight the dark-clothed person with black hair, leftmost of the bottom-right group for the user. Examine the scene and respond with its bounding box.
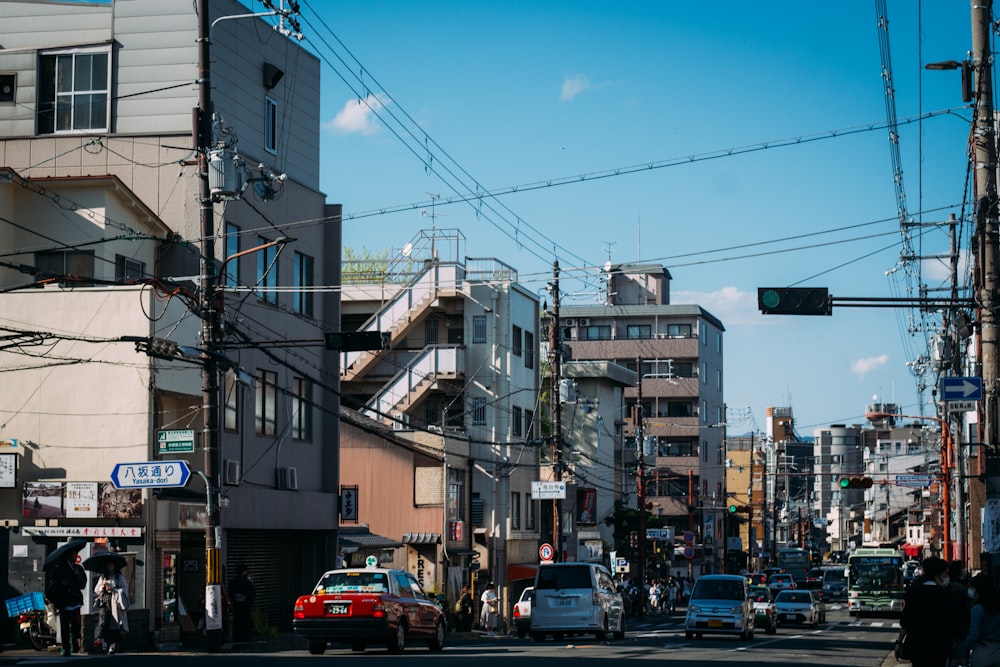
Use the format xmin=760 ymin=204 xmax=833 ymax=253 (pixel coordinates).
xmin=896 ymin=556 xmax=959 ymax=667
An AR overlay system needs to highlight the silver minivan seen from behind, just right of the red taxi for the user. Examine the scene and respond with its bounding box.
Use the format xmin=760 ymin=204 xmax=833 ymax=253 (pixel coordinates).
xmin=529 ymin=562 xmax=625 ymax=642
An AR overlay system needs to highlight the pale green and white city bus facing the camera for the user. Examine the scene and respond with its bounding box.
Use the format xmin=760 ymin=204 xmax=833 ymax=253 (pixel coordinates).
xmin=847 ymin=548 xmax=906 ymax=616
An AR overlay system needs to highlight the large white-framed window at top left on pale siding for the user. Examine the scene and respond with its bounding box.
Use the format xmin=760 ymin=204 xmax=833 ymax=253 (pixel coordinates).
xmin=38 ymin=47 xmax=111 ymax=134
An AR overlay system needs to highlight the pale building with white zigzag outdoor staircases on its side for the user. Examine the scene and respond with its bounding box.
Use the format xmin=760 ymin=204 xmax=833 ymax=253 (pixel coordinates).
xmin=341 ymin=229 xmax=540 ymax=608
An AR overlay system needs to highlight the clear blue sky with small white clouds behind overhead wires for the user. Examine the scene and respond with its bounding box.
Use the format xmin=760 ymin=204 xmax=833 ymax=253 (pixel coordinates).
xmin=292 ymin=0 xmax=971 ymax=435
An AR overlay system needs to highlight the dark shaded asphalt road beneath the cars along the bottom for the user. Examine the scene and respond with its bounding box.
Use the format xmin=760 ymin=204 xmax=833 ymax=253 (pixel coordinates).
xmin=0 ymin=604 xmax=898 ymax=667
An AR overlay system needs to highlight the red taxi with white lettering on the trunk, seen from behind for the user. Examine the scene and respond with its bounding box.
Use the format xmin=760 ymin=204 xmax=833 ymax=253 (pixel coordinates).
xmin=292 ymin=568 xmax=445 ymax=655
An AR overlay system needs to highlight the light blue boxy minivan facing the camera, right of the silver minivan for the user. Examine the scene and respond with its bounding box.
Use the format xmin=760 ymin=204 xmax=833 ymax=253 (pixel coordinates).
xmin=684 ymin=574 xmax=754 ymax=639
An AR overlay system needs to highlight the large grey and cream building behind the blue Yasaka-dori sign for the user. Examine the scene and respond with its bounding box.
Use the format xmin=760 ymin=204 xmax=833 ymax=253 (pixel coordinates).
xmin=0 ymin=0 xmax=340 ymax=637
